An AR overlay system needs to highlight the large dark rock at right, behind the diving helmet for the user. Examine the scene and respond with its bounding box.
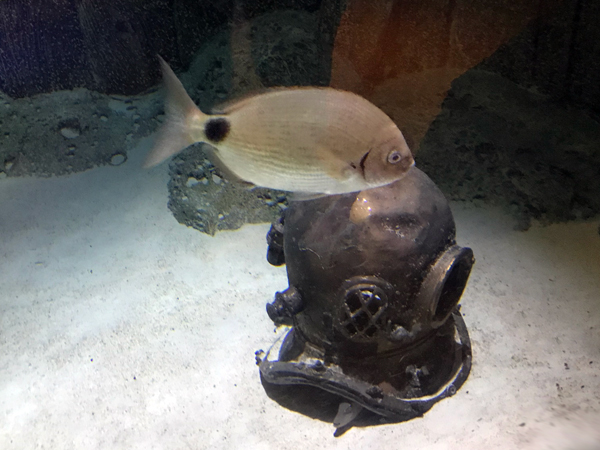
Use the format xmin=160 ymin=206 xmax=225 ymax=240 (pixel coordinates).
xmin=417 ymin=70 xmax=600 ymax=226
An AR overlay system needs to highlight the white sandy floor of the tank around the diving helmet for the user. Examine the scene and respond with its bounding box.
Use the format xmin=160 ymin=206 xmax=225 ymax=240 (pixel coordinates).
xmin=0 ymin=138 xmax=600 ymax=450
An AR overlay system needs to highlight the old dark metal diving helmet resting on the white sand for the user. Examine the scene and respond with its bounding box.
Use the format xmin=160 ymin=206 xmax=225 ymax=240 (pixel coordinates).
xmin=256 ymin=168 xmax=474 ymax=436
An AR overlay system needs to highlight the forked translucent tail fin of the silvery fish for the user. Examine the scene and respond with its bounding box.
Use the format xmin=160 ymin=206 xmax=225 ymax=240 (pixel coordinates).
xmin=144 ymin=56 xmax=208 ymax=168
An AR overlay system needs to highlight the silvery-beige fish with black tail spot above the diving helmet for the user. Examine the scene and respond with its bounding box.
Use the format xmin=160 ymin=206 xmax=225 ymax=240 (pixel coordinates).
xmin=144 ymin=57 xmax=414 ymax=196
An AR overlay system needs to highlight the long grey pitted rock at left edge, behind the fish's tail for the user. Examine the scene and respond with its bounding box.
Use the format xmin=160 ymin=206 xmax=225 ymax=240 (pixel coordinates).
xmin=0 ymin=89 xmax=163 ymax=176
